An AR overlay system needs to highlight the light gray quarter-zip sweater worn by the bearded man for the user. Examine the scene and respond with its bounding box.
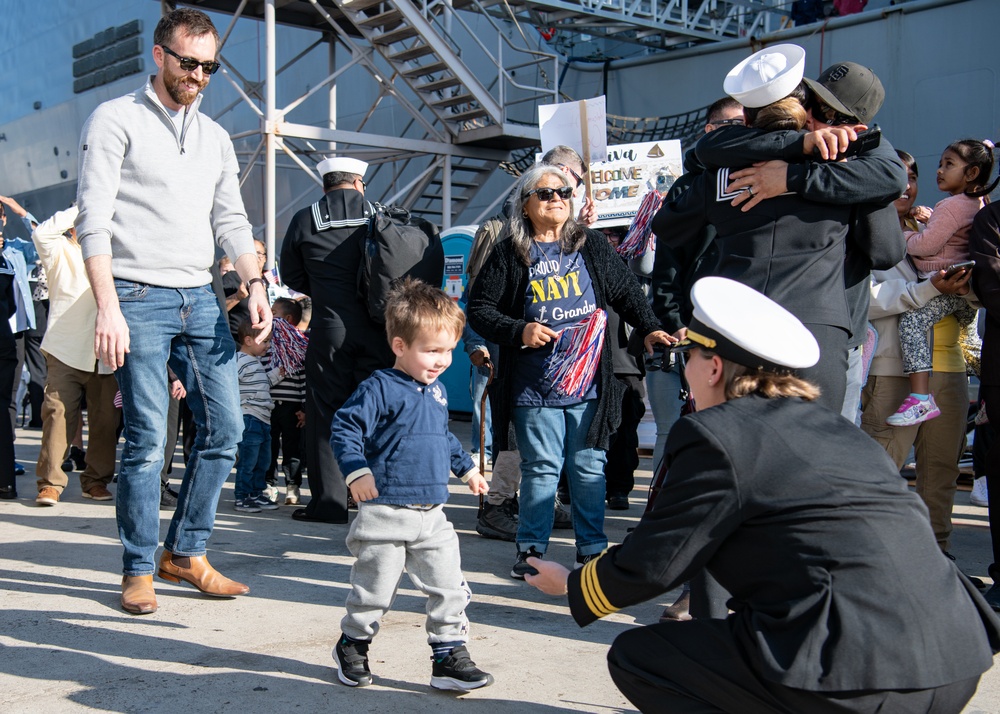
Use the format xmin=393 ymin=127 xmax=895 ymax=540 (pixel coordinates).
xmin=76 ymin=78 xmax=254 ymax=288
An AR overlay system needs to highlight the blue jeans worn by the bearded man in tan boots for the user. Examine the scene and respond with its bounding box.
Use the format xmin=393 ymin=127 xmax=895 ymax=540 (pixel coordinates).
xmin=115 ymin=280 xmax=242 ymax=575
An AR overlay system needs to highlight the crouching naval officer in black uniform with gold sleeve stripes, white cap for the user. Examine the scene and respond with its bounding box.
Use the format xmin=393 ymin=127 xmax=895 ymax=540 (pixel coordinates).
xmin=526 ymin=278 xmax=1000 ymax=714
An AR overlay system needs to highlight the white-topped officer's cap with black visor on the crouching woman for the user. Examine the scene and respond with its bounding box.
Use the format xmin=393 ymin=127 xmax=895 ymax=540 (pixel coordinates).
xmin=671 ymin=277 xmax=819 ymax=372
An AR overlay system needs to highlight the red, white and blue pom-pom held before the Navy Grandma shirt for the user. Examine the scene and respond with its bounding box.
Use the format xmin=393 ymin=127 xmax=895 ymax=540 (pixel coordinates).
xmin=545 ymin=309 xmax=608 ymax=397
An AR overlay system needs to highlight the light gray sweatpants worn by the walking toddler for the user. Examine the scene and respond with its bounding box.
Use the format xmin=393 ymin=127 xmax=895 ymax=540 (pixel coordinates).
xmin=340 ymin=503 xmax=472 ymax=645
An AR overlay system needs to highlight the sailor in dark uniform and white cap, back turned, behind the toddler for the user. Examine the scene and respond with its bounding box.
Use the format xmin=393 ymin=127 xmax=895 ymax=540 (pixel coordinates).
xmin=281 ymin=158 xmax=393 ymax=523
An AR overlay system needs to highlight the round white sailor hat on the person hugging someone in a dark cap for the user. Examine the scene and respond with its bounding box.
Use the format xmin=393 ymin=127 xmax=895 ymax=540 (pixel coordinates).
xmin=722 ymin=44 xmax=806 ymax=108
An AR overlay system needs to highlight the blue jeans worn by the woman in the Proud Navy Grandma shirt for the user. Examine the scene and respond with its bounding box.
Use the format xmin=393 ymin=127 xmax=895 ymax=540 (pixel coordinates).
xmin=514 ymin=399 xmax=608 ymax=555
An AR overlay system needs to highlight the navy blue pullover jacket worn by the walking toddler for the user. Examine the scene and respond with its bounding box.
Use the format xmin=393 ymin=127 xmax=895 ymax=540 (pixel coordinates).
xmin=330 ymin=369 xmax=476 ymax=506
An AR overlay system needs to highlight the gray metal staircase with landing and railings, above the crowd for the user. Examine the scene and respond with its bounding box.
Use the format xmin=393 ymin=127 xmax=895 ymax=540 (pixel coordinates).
xmin=330 ymin=0 xmax=558 ymax=223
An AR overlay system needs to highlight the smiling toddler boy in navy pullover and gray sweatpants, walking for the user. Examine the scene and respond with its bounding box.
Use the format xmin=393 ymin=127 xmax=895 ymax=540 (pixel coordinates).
xmin=330 ymin=280 xmax=493 ymax=691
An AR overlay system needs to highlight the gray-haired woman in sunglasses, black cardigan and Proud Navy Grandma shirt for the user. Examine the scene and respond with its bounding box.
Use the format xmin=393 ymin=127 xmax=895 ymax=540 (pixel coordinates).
xmin=468 ymin=166 xmax=674 ymax=579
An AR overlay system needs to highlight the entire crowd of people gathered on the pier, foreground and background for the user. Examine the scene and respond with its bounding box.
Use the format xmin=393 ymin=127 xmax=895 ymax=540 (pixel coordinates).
xmin=0 ymin=8 xmax=1000 ymax=712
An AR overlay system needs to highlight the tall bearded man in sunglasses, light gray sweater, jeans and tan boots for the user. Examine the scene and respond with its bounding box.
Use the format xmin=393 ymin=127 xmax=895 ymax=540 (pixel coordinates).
xmin=76 ymin=8 xmax=271 ymax=614
